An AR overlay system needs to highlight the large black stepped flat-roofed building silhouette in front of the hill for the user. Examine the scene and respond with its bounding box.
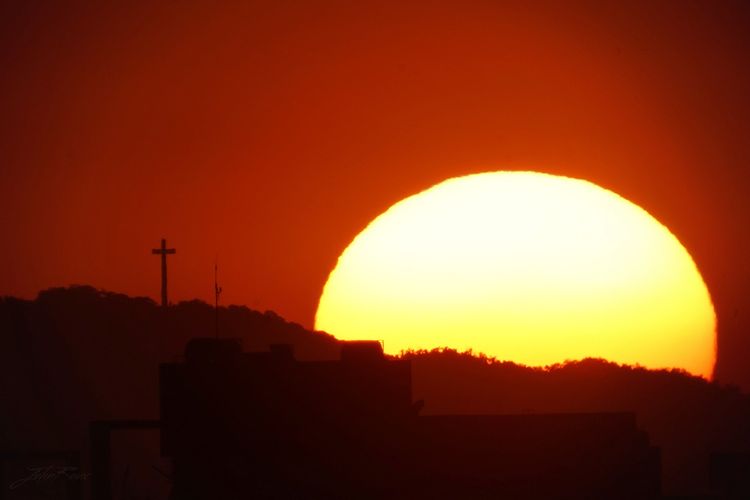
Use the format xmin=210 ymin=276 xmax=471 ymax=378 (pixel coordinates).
xmin=160 ymin=338 xmax=660 ymax=500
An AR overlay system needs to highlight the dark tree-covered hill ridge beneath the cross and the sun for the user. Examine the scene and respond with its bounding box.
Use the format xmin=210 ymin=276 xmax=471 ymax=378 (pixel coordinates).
xmin=0 ymin=286 xmax=750 ymax=494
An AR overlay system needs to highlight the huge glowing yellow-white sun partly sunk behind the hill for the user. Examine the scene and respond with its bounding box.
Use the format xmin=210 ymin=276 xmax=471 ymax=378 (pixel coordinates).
xmin=315 ymin=172 xmax=716 ymax=378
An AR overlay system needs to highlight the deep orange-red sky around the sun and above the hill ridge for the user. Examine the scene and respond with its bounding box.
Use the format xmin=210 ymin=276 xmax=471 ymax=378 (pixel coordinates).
xmin=0 ymin=0 xmax=750 ymax=390
